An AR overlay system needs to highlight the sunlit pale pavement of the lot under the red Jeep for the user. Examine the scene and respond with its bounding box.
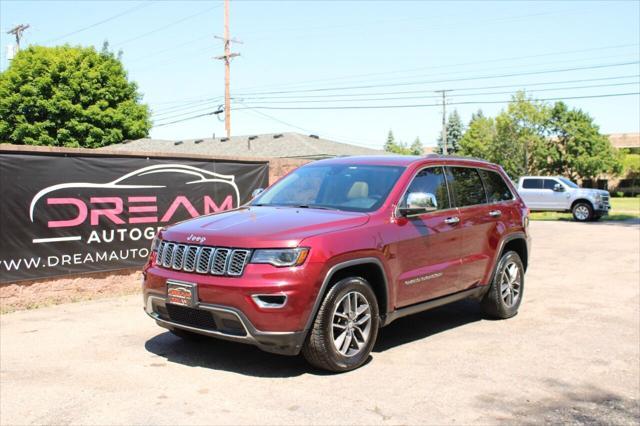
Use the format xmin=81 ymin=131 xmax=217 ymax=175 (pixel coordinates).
xmin=0 ymin=222 xmax=640 ymax=425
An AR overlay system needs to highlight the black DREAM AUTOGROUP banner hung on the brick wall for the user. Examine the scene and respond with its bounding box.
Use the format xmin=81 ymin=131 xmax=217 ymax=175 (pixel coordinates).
xmin=0 ymin=151 xmax=269 ymax=282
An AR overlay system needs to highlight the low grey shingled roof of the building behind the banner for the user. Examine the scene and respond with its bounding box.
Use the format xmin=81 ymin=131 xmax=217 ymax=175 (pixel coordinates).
xmin=105 ymin=133 xmax=386 ymax=160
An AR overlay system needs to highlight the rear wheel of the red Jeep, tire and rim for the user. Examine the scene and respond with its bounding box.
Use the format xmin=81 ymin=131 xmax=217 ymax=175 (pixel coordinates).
xmin=481 ymin=251 xmax=524 ymax=319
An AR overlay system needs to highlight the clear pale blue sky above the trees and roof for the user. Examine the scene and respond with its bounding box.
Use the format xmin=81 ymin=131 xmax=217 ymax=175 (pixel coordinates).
xmin=0 ymin=0 xmax=640 ymax=148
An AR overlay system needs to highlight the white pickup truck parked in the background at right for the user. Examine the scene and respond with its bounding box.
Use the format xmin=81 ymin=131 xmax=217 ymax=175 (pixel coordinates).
xmin=518 ymin=176 xmax=611 ymax=222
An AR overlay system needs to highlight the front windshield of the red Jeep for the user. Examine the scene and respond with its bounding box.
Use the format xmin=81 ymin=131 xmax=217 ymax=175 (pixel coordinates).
xmin=250 ymin=165 xmax=404 ymax=212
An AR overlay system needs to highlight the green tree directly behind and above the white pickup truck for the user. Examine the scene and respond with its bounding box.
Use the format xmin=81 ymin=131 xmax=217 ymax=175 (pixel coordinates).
xmin=538 ymin=102 xmax=623 ymax=180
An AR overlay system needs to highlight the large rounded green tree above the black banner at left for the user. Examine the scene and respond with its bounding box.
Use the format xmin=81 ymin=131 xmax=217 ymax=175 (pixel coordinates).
xmin=0 ymin=45 xmax=151 ymax=148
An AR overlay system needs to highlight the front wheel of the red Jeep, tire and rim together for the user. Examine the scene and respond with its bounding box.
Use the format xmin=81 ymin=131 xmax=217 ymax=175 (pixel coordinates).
xmin=302 ymin=277 xmax=380 ymax=372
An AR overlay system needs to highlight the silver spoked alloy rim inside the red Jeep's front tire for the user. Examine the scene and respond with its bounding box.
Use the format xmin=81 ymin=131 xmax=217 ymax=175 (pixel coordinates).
xmin=331 ymin=291 xmax=371 ymax=357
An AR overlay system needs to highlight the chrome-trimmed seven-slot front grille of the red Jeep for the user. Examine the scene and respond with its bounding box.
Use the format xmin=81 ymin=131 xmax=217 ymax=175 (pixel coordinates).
xmin=156 ymin=241 xmax=251 ymax=277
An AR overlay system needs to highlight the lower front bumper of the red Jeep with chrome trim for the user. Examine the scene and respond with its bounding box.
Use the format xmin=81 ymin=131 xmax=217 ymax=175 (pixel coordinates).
xmin=144 ymin=292 xmax=306 ymax=355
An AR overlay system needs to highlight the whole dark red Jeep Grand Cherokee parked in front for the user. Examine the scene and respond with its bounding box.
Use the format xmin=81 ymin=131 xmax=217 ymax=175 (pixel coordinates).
xmin=144 ymin=155 xmax=529 ymax=371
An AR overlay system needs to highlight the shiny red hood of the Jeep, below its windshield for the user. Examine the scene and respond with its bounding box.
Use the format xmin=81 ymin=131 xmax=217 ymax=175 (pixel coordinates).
xmin=162 ymin=207 xmax=369 ymax=248
